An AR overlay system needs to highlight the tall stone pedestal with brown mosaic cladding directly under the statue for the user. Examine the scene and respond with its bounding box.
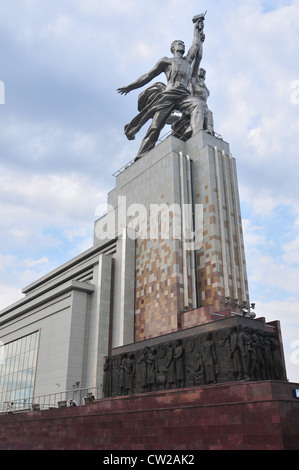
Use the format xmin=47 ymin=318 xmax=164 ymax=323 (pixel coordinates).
xmin=95 ymin=131 xmax=249 ymax=347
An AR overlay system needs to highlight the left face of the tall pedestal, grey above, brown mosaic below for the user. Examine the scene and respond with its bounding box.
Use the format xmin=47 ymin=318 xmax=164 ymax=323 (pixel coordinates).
xmin=108 ymin=138 xmax=188 ymax=341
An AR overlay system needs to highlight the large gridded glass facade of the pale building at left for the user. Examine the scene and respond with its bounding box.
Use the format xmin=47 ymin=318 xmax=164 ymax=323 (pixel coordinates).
xmin=0 ymin=331 xmax=39 ymax=411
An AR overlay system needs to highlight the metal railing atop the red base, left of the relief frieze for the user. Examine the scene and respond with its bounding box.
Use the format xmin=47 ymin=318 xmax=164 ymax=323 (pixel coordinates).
xmin=0 ymin=387 xmax=100 ymax=414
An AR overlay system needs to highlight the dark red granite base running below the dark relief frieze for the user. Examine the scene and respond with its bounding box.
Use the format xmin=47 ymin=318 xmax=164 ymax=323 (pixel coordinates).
xmin=0 ymin=381 xmax=299 ymax=451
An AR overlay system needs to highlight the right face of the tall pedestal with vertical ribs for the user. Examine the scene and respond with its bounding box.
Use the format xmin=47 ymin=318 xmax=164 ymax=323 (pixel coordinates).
xmin=185 ymin=132 xmax=250 ymax=311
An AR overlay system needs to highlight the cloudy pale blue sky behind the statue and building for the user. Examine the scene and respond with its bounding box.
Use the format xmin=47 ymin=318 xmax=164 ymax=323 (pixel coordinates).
xmin=0 ymin=0 xmax=299 ymax=382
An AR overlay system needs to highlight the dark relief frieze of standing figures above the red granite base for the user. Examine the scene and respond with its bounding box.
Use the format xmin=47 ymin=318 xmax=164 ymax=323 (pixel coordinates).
xmin=104 ymin=316 xmax=285 ymax=396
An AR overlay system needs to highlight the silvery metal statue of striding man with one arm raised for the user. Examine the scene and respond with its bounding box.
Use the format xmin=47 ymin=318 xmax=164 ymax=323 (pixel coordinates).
xmin=118 ymin=15 xmax=204 ymax=160
